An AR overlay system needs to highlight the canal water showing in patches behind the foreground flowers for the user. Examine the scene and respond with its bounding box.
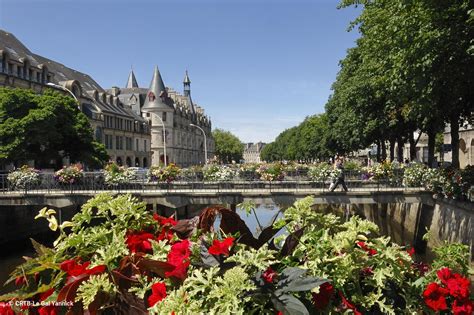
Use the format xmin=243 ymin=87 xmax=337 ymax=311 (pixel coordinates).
xmin=0 ymin=204 xmax=424 ymax=294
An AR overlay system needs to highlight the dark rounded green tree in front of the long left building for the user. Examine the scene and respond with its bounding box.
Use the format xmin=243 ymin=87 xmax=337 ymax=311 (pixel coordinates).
xmin=0 ymin=88 xmax=108 ymax=167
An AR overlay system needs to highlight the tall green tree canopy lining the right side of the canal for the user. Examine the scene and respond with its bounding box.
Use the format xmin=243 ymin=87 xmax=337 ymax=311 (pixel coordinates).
xmin=262 ymin=0 xmax=474 ymax=166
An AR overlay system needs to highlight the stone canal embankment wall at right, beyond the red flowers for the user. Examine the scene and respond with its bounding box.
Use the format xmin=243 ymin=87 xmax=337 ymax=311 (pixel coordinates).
xmin=321 ymin=199 xmax=474 ymax=263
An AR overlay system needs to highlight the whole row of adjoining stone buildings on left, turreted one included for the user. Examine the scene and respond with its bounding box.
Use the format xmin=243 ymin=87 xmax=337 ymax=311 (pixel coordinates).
xmin=0 ymin=30 xmax=214 ymax=167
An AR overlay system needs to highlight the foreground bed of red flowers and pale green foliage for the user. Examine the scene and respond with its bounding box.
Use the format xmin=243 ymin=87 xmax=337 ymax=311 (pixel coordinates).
xmin=0 ymin=194 xmax=473 ymax=314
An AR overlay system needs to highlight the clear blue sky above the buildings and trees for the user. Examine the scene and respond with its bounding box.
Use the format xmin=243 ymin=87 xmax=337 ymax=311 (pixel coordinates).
xmin=0 ymin=0 xmax=359 ymax=142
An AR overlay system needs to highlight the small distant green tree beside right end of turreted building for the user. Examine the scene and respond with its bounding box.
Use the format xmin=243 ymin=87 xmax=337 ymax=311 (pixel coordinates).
xmin=212 ymin=129 xmax=244 ymax=163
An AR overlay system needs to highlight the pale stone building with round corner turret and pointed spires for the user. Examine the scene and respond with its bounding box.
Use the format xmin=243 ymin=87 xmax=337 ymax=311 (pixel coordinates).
xmin=108 ymin=67 xmax=214 ymax=166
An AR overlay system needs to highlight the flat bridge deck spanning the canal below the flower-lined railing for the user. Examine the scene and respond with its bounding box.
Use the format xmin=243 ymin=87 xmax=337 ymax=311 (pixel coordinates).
xmin=0 ymin=183 xmax=433 ymax=208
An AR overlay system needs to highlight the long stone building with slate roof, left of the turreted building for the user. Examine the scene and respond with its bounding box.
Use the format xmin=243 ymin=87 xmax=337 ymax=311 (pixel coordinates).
xmin=0 ymin=30 xmax=151 ymax=167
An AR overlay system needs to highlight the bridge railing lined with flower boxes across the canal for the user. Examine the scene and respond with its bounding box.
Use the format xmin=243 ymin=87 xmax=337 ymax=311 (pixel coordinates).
xmin=0 ymin=171 xmax=413 ymax=193
